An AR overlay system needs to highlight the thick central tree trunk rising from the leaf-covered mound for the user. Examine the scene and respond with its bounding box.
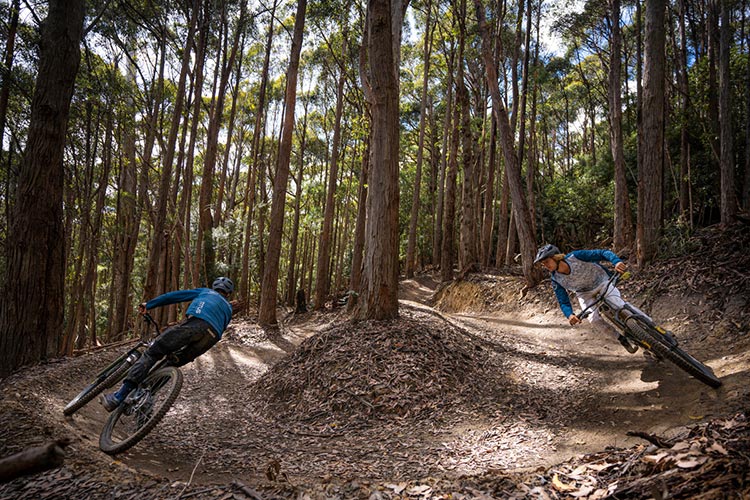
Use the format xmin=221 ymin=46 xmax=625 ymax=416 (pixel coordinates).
xmin=357 ymin=0 xmax=408 ymax=319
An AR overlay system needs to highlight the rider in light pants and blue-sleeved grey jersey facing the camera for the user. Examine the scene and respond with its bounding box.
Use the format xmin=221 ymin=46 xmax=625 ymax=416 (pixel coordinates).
xmin=534 ymin=244 xmax=646 ymax=353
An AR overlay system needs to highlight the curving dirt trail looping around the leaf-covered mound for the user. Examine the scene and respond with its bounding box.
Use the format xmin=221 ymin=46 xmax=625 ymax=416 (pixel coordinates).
xmin=0 ymin=277 xmax=750 ymax=498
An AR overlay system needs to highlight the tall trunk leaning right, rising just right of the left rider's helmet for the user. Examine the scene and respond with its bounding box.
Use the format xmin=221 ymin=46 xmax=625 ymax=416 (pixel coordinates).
xmin=258 ymin=0 xmax=307 ymax=326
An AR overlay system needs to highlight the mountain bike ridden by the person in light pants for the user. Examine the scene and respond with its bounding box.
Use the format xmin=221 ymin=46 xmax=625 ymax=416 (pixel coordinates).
xmin=577 ymin=272 xmax=721 ymax=389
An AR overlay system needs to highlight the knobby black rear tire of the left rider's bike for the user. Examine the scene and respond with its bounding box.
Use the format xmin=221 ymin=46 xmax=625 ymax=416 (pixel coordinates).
xmin=99 ymin=366 xmax=182 ymax=455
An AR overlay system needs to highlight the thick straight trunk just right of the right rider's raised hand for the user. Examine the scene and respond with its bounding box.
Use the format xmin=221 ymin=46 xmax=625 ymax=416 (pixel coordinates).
xmin=638 ymin=0 xmax=666 ymax=267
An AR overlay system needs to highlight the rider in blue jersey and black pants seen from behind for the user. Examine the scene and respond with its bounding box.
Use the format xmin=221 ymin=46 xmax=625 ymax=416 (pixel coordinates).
xmin=101 ymin=277 xmax=234 ymax=411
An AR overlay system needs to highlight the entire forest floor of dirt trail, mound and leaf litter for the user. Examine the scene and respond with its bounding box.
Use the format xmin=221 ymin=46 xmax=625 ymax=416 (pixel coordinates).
xmin=0 ymin=224 xmax=750 ymax=499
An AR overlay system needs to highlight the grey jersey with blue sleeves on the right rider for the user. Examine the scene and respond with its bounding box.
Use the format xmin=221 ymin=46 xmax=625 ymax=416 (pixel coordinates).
xmin=551 ymin=250 xmax=622 ymax=318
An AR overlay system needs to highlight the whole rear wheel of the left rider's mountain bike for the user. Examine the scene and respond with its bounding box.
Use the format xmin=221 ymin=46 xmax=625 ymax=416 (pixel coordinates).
xmin=99 ymin=366 xmax=182 ymax=455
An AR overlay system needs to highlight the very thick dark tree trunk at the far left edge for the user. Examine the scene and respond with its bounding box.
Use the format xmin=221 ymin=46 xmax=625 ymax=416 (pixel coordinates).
xmin=0 ymin=0 xmax=85 ymax=377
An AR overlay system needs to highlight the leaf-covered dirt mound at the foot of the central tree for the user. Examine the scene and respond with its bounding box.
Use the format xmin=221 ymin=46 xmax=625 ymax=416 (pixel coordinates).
xmin=250 ymin=309 xmax=503 ymax=428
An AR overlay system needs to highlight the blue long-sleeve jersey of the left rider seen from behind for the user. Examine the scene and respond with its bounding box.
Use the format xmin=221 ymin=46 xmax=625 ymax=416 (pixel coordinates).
xmin=146 ymin=288 xmax=232 ymax=339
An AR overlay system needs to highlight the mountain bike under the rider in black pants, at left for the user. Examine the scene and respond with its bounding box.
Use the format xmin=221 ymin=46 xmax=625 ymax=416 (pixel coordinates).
xmin=63 ymin=314 xmax=182 ymax=455
